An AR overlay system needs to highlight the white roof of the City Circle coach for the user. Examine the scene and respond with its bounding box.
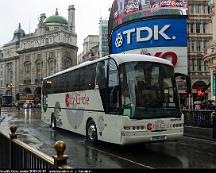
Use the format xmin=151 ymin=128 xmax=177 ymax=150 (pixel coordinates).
xmin=44 ymin=54 xmax=173 ymax=80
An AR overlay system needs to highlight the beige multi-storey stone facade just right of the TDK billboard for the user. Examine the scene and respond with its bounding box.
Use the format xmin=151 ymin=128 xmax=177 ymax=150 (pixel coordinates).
xmin=188 ymin=0 xmax=212 ymax=101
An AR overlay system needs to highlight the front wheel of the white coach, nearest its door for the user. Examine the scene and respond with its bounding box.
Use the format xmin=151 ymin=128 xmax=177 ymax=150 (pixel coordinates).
xmin=86 ymin=120 xmax=98 ymax=143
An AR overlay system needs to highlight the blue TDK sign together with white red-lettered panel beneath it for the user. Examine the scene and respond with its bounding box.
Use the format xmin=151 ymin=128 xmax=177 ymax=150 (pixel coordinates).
xmin=111 ymin=18 xmax=188 ymax=74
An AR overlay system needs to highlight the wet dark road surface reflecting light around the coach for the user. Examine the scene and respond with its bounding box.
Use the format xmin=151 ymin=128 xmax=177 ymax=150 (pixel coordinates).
xmin=0 ymin=108 xmax=216 ymax=169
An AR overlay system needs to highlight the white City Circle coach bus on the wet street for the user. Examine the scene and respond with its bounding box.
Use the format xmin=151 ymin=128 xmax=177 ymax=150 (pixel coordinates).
xmin=41 ymin=54 xmax=189 ymax=145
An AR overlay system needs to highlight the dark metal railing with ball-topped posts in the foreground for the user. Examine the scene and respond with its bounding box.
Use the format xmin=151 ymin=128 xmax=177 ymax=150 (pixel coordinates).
xmin=0 ymin=125 xmax=72 ymax=170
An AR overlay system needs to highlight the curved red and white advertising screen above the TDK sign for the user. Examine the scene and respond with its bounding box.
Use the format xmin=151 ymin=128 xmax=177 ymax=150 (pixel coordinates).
xmin=109 ymin=0 xmax=188 ymax=29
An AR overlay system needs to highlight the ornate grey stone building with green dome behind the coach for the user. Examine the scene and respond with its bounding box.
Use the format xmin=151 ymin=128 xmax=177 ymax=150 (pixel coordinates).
xmin=0 ymin=5 xmax=78 ymax=103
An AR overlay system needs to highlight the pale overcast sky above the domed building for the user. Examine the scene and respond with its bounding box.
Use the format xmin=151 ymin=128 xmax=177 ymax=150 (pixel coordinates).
xmin=0 ymin=0 xmax=114 ymax=52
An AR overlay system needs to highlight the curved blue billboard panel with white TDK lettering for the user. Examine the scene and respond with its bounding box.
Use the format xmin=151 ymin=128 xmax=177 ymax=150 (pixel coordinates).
xmin=112 ymin=19 xmax=187 ymax=54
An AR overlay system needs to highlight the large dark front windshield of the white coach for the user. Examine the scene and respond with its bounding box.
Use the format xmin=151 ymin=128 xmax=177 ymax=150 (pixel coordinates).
xmin=120 ymin=62 xmax=181 ymax=119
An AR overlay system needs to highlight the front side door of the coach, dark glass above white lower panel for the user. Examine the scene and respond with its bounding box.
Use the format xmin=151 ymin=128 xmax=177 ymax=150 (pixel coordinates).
xmin=96 ymin=59 xmax=122 ymax=143
